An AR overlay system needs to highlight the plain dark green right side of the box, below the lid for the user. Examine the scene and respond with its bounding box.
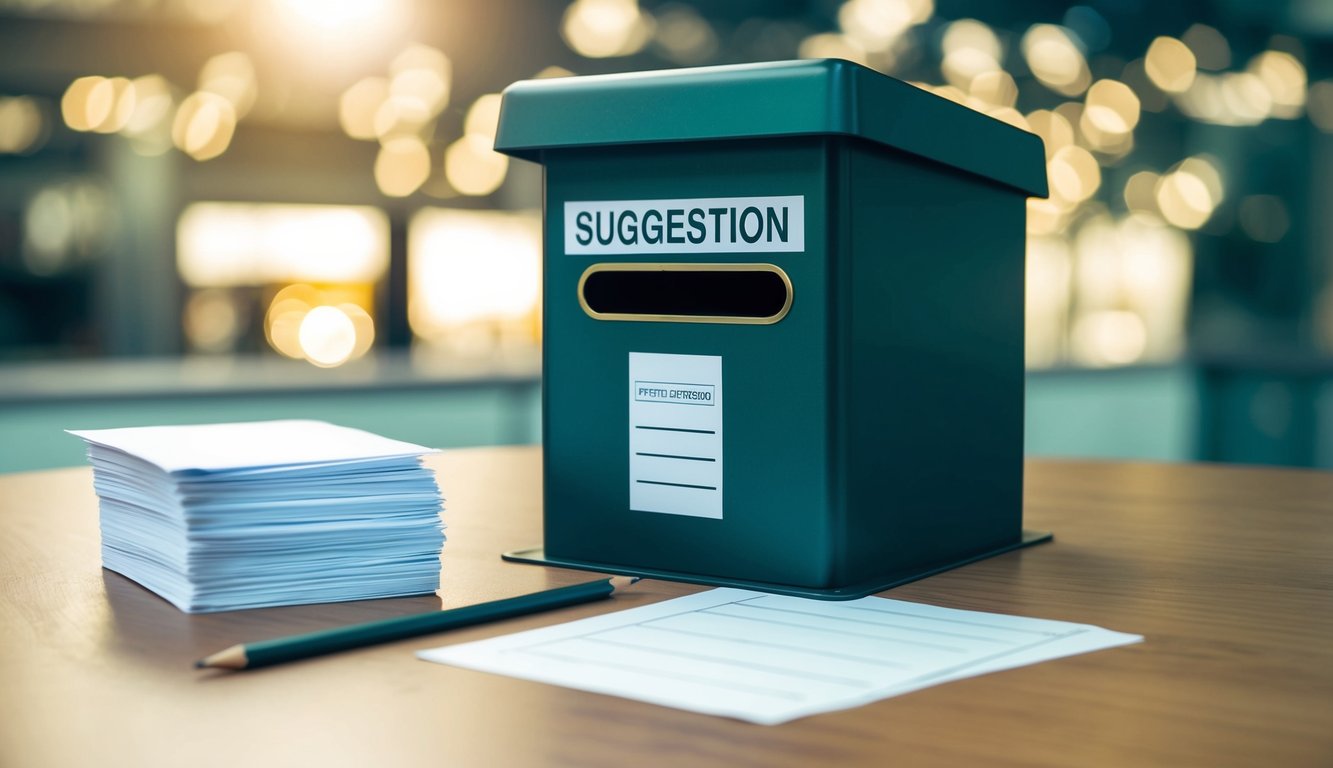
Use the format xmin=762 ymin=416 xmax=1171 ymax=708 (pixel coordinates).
xmin=840 ymin=140 xmax=1025 ymax=581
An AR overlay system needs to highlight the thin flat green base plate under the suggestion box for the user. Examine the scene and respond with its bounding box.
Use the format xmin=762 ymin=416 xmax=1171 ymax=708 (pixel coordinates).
xmin=501 ymin=529 xmax=1052 ymax=600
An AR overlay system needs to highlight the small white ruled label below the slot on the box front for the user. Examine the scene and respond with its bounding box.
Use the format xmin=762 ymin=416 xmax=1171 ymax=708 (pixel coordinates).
xmin=629 ymin=352 xmax=722 ymax=520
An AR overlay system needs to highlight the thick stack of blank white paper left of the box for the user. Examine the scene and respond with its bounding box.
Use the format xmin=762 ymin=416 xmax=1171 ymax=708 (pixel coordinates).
xmin=71 ymin=421 xmax=444 ymax=612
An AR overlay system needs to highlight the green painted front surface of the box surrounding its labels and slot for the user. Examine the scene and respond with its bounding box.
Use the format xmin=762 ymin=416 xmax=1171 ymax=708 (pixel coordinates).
xmin=543 ymin=139 xmax=833 ymax=587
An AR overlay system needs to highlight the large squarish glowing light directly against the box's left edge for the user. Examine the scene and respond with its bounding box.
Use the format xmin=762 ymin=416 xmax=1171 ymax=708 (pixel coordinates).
xmin=408 ymin=208 xmax=541 ymax=344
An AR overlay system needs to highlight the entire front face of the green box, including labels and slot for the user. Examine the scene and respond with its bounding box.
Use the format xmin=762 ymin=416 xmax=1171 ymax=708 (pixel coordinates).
xmin=543 ymin=139 xmax=832 ymax=587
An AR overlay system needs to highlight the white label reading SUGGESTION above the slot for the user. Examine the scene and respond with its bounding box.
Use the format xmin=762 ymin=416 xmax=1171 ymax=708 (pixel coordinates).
xmin=565 ymin=195 xmax=805 ymax=256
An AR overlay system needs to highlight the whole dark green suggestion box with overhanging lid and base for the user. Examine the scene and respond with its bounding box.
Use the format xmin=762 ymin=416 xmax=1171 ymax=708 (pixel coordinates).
xmin=496 ymin=60 xmax=1049 ymax=599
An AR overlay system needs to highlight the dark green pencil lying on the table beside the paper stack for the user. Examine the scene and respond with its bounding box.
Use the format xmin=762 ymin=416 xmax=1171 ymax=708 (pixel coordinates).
xmin=195 ymin=576 xmax=639 ymax=669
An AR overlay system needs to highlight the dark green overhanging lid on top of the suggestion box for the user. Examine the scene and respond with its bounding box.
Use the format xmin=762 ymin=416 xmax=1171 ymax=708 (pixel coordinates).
xmin=496 ymin=59 xmax=1046 ymax=196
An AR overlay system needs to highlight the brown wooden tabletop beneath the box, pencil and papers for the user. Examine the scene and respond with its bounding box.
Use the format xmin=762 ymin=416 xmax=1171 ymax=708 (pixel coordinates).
xmin=0 ymin=448 xmax=1333 ymax=768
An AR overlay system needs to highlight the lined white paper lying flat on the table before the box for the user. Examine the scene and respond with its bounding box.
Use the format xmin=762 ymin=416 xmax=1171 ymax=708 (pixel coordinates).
xmin=419 ymin=589 xmax=1142 ymax=725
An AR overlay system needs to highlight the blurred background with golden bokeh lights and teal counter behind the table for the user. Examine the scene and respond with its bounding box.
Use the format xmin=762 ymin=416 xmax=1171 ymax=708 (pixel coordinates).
xmin=0 ymin=0 xmax=1333 ymax=471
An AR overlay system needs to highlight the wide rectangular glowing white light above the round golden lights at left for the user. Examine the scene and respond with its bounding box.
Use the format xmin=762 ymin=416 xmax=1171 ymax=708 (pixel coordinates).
xmin=176 ymin=203 xmax=389 ymax=287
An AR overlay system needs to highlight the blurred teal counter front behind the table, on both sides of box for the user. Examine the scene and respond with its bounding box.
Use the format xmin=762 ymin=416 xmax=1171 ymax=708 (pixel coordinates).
xmin=0 ymin=365 xmax=1333 ymax=472
